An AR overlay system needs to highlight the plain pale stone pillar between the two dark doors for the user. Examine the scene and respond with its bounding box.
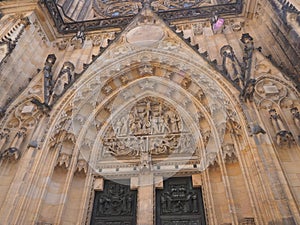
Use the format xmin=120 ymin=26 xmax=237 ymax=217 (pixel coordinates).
xmin=137 ymin=172 xmax=154 ymax=225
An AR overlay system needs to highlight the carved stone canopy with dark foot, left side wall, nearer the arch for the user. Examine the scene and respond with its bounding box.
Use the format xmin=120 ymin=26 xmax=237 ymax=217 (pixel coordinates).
xmin=0 ymin=127 xmax=27 ymax=160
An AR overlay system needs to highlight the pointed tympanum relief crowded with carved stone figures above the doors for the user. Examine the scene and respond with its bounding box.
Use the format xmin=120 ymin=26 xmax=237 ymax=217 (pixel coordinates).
xmin=102 ymin=97 xmax=195 ymax=157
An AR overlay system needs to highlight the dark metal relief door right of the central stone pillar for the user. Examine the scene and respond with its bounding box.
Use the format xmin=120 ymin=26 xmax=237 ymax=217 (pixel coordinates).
xmin=156 ymin=177 xmax=206 ymax=225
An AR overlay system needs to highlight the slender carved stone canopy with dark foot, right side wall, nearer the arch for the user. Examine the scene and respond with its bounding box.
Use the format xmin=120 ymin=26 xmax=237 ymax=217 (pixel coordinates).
xmin=269 ymin=109 xmax=294 ymax=147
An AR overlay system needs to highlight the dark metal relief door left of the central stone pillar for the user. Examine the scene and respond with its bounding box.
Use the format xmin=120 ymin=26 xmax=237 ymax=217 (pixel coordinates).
xmin=91 ymin=180 xmax=137 ymax=225
